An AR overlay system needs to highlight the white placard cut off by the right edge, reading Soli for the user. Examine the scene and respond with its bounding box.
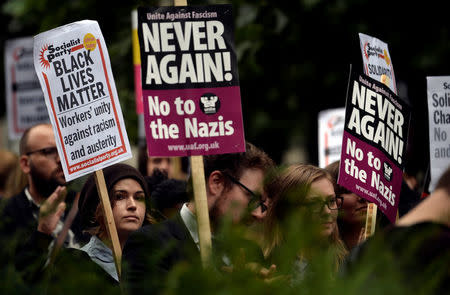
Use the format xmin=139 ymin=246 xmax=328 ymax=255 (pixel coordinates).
xmin=427 ymin=76 xmax=450 ymax=191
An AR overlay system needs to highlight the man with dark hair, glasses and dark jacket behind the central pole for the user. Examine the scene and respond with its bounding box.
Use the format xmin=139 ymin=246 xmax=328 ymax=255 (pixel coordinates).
xmin=123 ymin=143 xmax=273 ymax=293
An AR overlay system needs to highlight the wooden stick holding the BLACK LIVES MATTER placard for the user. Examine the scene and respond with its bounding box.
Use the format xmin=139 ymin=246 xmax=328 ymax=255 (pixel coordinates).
xmin=95 ymin=169 xmax=122 ymax=281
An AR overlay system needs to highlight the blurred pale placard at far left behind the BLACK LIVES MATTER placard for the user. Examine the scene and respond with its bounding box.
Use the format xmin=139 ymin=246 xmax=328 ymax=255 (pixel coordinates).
xmin=5 ymin=37 xmax=49 ymax=140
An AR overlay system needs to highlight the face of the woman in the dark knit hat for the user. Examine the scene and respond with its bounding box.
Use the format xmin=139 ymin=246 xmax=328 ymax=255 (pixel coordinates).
xmin=112 ymin=178 xmax=146 ymax=242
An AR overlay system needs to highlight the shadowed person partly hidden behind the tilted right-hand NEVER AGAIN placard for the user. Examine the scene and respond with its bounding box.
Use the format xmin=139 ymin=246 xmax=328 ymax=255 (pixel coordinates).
xmin=325 ymin=161 xmax=368 ymax=251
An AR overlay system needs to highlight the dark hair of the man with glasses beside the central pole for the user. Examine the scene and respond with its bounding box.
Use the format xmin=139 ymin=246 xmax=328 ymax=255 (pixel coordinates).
xmin=203 ymin=142 xmax=275 ymax=192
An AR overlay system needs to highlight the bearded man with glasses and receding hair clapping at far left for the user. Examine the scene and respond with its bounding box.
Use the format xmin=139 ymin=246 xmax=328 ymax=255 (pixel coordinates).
xmin=0 ymin=124 xmax=84 ymax=276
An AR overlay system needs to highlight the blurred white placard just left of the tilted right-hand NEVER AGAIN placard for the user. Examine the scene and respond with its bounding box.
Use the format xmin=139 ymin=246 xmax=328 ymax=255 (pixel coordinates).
xmin=319 ymin=108 xmax=345 ymax=168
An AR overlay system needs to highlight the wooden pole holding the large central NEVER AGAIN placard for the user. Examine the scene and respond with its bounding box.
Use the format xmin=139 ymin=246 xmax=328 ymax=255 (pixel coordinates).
xmin=174 ymin=0 xmax=212 ymax=267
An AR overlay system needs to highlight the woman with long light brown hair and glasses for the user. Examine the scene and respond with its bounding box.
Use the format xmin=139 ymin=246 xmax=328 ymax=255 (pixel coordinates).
xmin=264 ymin=164 xmax=347 ymax=283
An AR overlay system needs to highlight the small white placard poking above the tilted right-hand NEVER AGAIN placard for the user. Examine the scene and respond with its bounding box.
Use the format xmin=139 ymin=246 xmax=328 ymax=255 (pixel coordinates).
xmin=359 ymin=33 xmax=397 ymax=94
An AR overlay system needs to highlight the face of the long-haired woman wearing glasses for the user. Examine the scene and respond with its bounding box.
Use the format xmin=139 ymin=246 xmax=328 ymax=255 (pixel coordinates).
xmin=306 ymin=178 xmax=338 ymax=237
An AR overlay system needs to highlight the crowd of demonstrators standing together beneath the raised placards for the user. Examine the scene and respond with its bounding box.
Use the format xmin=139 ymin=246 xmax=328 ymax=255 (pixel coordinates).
xmin=0 ymin=124 xmax=450 ymax=294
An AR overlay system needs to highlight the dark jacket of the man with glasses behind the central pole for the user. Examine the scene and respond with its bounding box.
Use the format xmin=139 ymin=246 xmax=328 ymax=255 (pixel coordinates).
xmin=122 ymin=213 xmax=264 ymax=294
